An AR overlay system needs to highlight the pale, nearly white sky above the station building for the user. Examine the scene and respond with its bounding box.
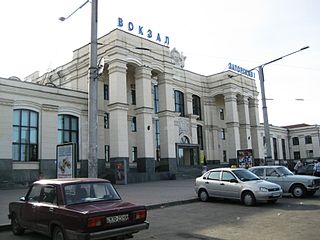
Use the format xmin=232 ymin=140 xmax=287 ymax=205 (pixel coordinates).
xmin=0 ymin=0 xmax=320 ymax=126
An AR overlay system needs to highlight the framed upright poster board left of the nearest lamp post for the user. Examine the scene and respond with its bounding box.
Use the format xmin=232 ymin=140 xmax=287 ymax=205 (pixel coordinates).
xmin=56 ymin=143 xmax=77 ymax=178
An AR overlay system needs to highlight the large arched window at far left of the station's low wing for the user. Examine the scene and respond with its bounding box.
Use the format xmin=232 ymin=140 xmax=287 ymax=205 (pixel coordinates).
xmin=12 ymin=109 xmax=39 ymax=162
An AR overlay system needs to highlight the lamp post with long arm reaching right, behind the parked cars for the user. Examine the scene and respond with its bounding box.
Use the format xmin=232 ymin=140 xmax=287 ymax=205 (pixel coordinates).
xmin=254 ymin=46 xmax=309 ymax=165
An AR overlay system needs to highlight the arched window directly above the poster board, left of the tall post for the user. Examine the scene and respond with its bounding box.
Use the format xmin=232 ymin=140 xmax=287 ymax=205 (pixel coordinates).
xmin=58 ymin=114 xmax=79 ymax=144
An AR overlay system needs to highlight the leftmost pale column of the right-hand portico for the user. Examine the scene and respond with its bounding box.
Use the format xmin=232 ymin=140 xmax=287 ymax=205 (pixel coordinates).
xmin=224 ymin=92 xmax=240 ymax=164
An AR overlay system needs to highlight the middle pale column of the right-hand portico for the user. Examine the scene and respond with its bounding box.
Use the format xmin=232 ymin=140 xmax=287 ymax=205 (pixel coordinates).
xmin=238 ymin=96 xmax=252 ymax=149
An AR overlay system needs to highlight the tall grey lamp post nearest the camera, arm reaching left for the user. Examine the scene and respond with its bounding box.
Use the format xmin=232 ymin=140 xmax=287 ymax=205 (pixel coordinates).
xmin=59 ymin=0 xmax=98 ymax=178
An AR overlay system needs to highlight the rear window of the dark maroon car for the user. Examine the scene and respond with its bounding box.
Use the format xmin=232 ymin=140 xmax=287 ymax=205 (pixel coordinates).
xmin=64 ymin=182 xmax=120 ymax=205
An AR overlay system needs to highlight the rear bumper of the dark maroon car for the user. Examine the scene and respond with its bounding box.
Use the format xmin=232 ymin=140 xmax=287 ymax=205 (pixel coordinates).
xmin=66 ymin=221 xmax=149 ymax=240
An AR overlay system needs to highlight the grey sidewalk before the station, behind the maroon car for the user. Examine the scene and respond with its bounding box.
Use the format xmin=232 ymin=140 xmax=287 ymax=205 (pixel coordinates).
xmin=0 ymin=179 xmax=197 ymax=231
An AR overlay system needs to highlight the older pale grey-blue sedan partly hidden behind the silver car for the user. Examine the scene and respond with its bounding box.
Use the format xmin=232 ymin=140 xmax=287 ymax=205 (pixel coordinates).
xmin=249 ymin=166 xmax=320 ymax=198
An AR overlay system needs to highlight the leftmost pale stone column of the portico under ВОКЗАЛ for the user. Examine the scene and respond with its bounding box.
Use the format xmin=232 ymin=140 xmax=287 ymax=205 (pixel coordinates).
xmin=108 ymin=60 xmax=129 ymax=180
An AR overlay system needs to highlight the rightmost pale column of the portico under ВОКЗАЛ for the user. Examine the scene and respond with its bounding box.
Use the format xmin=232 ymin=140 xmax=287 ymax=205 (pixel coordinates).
xmin=158 ymin=73 xmax=177 ymax=173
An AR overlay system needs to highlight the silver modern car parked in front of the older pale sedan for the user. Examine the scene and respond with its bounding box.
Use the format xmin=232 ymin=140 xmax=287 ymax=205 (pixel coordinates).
xmin=195 ymin=168 xmax=282 ymax=206
